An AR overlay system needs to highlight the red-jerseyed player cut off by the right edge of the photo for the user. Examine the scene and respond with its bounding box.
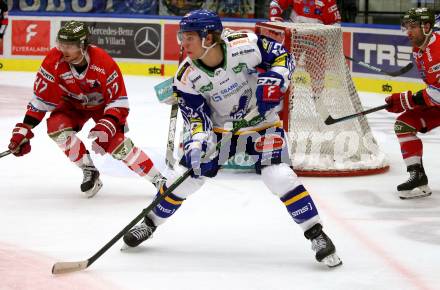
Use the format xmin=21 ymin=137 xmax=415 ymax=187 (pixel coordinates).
xmin=386 ymin=8 xmax=440 ymax=199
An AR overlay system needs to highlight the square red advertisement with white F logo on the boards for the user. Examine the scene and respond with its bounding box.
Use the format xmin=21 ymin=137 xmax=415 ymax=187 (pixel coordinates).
xmin=11 ymin=20 xmax=50 ymax=55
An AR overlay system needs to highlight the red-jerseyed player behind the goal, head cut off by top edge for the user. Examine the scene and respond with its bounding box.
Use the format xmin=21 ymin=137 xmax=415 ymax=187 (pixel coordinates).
xmin=269 ymin=0 xmax=341 ymax=24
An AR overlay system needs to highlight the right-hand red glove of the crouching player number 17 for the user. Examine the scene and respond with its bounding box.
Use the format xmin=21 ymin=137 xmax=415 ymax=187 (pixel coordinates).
xmin=88 ymin=117 xmax=117 ymax=155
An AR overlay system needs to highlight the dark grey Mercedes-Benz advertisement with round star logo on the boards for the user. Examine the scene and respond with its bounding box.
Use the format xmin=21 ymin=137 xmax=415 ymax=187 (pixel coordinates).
xmin=61 ymin=22 xmax=162 ymax=60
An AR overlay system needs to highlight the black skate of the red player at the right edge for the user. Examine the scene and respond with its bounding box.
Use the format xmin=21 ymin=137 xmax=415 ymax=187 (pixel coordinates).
xmin=397 ymin=164 xmax=432 ymax=199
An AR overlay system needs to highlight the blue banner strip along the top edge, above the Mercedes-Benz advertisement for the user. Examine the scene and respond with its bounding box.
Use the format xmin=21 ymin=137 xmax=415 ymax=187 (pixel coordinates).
xmin=10 ymin=0 xmax=159 ymax=14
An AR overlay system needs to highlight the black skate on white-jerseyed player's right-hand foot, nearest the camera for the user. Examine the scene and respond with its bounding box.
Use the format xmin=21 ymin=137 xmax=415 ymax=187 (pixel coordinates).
xmin=304 ymin=224 xmax=342 ymax=268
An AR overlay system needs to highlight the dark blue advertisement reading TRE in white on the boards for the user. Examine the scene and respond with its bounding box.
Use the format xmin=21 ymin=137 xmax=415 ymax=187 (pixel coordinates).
xmin=352 ymin=32 xmax=419 ymax=78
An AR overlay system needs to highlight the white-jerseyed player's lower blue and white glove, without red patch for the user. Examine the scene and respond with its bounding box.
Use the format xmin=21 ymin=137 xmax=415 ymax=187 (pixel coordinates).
xmin=184 ymin=133 xmax=214 ymax=177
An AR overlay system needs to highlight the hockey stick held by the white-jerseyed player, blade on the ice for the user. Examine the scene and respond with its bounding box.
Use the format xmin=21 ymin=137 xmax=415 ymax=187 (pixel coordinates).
xmin=52 ymin=108 xmax=263 ymax=274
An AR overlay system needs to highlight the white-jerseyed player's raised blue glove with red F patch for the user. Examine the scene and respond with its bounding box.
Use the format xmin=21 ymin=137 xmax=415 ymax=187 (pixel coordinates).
xmin=256 ymin=71 xmax=284 ymax=116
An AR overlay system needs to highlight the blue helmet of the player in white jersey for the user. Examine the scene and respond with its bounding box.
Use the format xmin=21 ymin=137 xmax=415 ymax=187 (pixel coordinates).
xmin=178 ymin=9 xmax=223 ymax=39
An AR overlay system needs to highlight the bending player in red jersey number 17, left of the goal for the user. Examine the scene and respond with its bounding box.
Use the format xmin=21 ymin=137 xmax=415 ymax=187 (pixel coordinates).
xmin=9 ymin=21 xmax=163 ymax=197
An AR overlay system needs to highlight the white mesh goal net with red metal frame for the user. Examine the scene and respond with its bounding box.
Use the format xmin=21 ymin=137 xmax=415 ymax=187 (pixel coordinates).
xmin=256 ymin=22 xmax=389 ymax=176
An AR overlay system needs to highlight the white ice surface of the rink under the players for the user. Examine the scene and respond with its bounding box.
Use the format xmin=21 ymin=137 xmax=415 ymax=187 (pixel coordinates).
xmin=0 ymin=72 xmax=440 ymax=290
